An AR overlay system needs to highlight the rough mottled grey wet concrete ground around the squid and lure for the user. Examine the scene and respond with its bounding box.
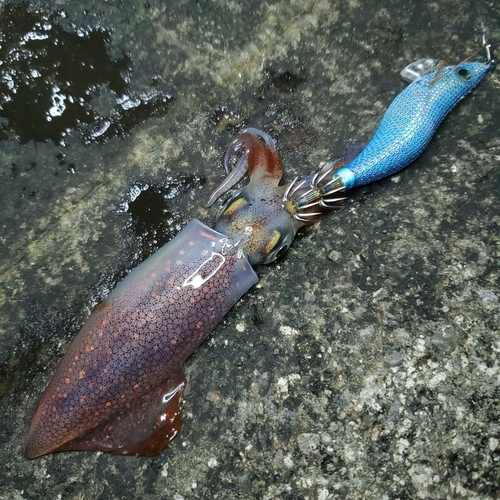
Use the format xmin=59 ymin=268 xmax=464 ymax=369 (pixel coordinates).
xmin=0 ymin=0 xmax=500 ymax=500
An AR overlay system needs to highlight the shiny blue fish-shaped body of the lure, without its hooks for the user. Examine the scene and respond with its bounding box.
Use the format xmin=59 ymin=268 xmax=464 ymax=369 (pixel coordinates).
xmin=334 ymin=62 xmax=494 ymax=190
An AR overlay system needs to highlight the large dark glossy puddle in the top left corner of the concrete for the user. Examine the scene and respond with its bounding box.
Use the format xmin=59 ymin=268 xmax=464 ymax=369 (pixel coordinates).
xmin=0 ymin=3 xmax=171 ymax=144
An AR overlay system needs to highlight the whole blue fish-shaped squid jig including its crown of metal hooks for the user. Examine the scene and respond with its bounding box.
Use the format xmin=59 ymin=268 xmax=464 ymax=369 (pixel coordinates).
xmin=284 ymin=55 xmax=495 ymax=223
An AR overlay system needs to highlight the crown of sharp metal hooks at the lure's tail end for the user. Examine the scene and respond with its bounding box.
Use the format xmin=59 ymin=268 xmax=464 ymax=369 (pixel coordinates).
xmin=283 ymin=159 xmax=346 ymax=224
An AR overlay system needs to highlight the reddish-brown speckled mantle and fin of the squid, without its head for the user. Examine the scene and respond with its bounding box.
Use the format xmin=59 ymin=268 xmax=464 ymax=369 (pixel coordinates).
xmin=25 ymin=219 xmax=258 ymax=459
